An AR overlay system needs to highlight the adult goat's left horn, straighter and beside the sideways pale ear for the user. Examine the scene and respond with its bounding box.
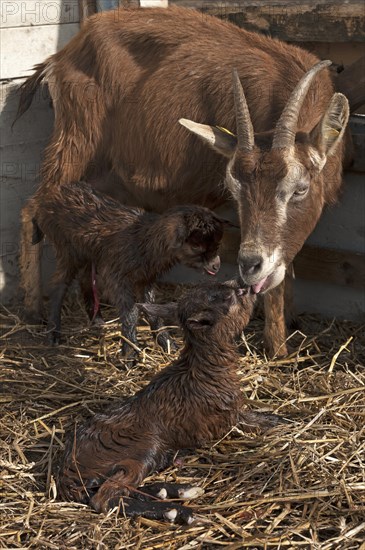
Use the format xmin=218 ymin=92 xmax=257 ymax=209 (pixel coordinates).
xmin=233 ymin=69 xmax=255 ymax=151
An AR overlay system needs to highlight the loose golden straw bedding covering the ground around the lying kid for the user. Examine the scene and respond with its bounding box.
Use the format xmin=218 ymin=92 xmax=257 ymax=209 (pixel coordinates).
xmin=0 ymin=288 xmax=365 ymax=550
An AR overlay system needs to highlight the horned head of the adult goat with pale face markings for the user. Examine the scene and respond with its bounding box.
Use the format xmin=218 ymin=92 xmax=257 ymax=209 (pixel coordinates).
xmin=180 ymin=61 xmax=349 ymax=293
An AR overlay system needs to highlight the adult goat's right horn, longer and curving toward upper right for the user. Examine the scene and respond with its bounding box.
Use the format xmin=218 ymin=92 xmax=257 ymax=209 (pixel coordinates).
xmin=272 ymin=59 xmax=332 ymax=149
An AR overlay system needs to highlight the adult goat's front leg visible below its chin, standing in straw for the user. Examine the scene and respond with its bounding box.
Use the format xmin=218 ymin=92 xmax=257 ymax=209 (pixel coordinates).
xmin=264 ymin=281 xmax=288 ymax=357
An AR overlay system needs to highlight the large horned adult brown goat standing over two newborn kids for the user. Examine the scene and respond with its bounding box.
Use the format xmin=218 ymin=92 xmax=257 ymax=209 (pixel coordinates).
xmin=15 ymin=7 xmax=349 ymax=354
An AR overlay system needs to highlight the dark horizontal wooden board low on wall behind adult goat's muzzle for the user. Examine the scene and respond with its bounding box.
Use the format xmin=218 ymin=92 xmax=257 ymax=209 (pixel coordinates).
xmin=221 ymin=230 xmax=365 ymax=290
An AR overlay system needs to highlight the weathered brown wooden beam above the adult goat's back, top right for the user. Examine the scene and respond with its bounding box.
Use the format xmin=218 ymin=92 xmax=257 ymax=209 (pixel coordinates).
xmin=169 ymin=0 xmax=365 ymax=42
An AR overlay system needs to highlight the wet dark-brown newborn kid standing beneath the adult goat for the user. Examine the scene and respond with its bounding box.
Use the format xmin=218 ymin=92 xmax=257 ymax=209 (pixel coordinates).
xmin=33 ymin=182 xmax=225 ymax=356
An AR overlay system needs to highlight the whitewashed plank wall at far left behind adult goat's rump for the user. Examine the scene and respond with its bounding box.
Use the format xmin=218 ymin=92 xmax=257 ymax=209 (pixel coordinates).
xmin=0 ymin=0 xmax=79 ymax=301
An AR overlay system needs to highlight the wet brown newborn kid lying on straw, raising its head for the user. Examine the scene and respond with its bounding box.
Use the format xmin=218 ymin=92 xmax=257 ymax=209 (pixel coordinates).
xmin=58 ymin=281 xmax=280 ymax=522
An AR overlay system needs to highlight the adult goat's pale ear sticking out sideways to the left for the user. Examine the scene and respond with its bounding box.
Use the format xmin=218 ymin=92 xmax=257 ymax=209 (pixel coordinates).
xmin=179 ymin=118 xmax=237 ymax=158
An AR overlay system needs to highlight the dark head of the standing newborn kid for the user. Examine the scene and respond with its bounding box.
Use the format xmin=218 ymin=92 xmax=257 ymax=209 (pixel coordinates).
xmin=165 ymin=205 xmax=226 ymax=275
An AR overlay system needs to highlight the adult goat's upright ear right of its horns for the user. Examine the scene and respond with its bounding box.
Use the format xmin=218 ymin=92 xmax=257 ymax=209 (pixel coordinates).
xmin=311 ymin=93 xmax=350 ymax=157
